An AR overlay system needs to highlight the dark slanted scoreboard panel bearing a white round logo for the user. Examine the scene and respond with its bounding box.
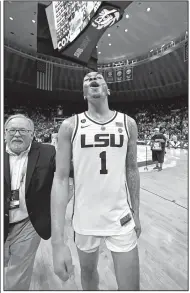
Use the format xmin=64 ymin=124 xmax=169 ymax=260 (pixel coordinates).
xmin=58 ymin=1 xmax=133 ymax=66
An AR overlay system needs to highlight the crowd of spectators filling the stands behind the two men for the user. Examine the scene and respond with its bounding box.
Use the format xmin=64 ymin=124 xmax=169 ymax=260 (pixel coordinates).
xmin=5 ymin=97 xmax=188 ymax=147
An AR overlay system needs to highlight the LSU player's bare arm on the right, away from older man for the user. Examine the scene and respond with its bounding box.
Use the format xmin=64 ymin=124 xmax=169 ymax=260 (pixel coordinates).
xmin=126 ymin=117 xmax=141 ymax=237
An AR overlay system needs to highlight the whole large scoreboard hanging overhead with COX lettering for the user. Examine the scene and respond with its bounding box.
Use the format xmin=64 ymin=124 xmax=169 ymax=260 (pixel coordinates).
xmin=37 ymin=1 xmax=133 ymax=70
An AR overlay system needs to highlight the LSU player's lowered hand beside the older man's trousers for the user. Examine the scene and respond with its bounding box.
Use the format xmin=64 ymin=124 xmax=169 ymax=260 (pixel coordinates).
xmin=53 ymin=244 xmax=74 ymax=282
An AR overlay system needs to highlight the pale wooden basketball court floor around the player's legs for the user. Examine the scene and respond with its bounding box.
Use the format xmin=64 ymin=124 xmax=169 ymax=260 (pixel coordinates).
xmin=30 ymin=148 xmax=188 ymax=290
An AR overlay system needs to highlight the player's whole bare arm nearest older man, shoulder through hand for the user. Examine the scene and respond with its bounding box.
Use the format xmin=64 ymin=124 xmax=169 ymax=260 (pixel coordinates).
xmin=51 ymin=117 xmax=74 ymax=281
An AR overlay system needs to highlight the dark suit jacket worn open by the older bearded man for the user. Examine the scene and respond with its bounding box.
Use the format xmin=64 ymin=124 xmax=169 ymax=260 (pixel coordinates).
xmin=4 ymin=142 xmax=55 ymax=241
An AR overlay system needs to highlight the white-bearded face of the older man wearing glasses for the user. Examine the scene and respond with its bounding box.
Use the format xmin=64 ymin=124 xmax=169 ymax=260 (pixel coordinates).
xmin=5 ymin=118 xmax=34 ymax=154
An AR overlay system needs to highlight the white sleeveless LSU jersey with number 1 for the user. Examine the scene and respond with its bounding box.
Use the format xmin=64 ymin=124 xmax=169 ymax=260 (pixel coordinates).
xmin=72 ymin=112 xmax=135 ymax=236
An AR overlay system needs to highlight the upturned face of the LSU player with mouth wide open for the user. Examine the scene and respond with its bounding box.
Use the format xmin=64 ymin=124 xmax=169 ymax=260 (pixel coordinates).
xmin=83 ymin=72 xmax=109 ymax=100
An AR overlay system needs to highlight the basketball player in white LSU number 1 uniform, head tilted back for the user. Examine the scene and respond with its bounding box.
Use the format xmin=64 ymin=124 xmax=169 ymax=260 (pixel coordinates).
xmin=51 ymin=72 xmax=141 ymax=290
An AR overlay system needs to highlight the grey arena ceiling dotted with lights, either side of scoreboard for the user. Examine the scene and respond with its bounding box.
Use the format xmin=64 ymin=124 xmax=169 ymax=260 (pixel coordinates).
xmin=4 ymin=0 xmax=188 ymax=63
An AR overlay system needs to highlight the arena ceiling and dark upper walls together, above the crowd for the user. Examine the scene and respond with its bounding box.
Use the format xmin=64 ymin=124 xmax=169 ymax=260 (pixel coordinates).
xmin=4 ymin=1 xmax=188 ymax=143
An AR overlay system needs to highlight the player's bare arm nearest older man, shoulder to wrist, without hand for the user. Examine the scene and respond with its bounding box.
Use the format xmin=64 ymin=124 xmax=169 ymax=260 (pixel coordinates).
xmin=51 ymin=117 xmax=74 ymax=244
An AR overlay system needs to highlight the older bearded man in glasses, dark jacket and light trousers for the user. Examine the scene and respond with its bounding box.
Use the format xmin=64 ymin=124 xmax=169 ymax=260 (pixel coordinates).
xmin=4 ymin=114 xmax=55 ymax=290
